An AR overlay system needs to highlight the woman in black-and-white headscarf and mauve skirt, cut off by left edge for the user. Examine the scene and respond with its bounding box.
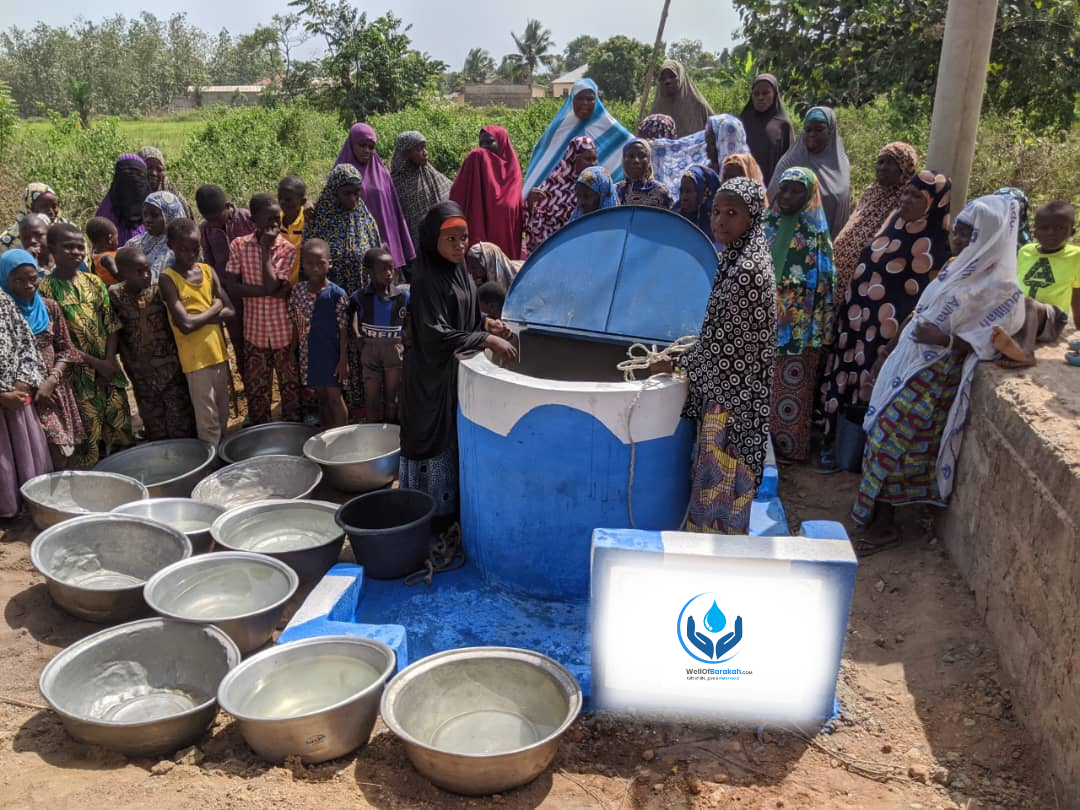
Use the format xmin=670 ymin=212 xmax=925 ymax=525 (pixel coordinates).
xmin=0 ymin=282 xmax=53 ymax=517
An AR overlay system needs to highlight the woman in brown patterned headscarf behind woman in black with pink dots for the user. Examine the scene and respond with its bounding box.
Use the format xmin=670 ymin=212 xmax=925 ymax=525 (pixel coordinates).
xmin=833 ymin=140 xmax=918 ymax=299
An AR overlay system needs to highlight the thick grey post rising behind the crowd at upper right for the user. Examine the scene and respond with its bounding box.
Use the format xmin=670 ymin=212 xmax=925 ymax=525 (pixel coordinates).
xmin=927 ymin=0 xmax=998 ymax=212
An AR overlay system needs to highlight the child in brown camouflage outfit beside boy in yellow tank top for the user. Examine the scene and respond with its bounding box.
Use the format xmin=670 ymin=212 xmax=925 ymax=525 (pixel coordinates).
xmin=105 ymin=244 xmax=195 ymax=442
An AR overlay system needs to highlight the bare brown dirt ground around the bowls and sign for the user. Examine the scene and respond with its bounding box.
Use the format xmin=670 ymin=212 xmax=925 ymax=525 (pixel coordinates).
xmin=0 ymin=468 xmax=1063 ymax=810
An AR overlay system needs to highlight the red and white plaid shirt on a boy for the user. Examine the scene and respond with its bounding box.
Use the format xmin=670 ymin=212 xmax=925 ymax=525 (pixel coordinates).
xmin=226 ymin=233 xmax=296 ymax=349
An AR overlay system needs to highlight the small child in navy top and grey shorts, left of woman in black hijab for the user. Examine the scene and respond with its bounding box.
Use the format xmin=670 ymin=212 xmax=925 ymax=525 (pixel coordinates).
xmin=350 ymin=247 xmax=408 ymax=422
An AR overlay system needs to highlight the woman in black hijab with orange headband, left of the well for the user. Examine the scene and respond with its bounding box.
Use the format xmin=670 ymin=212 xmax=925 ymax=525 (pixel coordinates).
xmin=399 ymin=202 xmax=517 ymax=528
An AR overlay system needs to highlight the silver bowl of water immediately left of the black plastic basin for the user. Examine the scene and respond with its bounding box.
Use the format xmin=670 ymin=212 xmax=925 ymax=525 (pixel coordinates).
xmin=210 ymin=500 xmax=345 ymax=582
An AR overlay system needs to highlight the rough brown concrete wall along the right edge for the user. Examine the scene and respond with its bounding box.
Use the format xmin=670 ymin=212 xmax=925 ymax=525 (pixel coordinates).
xmin=939 ymin=345 xmax=1080 ymax=807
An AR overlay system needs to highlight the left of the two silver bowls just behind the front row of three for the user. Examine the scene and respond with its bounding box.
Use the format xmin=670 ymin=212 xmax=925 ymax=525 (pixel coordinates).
xmin=30 ymin=514 xmax=191 ymax=623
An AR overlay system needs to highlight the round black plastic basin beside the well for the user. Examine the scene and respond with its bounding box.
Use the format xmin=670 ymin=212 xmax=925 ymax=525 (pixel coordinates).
xmin=335 ymin=489 xmax=435 ymax=579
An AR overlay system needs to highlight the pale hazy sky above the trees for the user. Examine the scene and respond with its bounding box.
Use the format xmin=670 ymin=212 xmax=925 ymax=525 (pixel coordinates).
xmin=3 ymin=0 xmax=739 ymax=69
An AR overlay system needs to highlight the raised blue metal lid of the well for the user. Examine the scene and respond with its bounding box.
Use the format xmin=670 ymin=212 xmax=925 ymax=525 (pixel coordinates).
xmin=502 ymin=205 xmax=717 ymax=343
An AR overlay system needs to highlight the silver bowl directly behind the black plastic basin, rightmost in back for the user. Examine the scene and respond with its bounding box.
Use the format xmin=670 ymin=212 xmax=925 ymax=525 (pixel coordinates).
xmin=303 ymin=424 xmax=401 ymax=492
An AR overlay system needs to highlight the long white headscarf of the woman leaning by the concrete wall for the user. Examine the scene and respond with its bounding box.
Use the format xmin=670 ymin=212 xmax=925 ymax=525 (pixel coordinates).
xmin=863 ymin=194 xmax=1024 ymax=499
